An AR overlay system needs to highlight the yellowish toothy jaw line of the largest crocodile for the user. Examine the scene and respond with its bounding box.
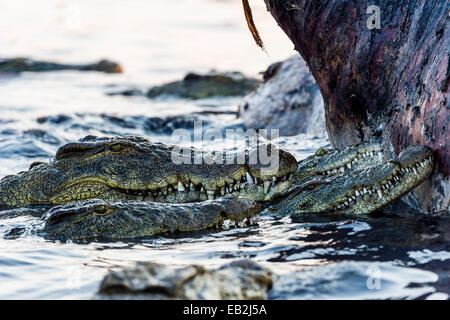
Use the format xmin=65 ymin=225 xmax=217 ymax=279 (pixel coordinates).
xmin=52 ymin=170 xmax=292 ymax=203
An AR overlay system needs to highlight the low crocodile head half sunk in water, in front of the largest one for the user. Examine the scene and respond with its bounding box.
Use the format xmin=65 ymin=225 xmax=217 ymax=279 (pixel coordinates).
xmin=41 ymin=195 xmax=260 ymax=240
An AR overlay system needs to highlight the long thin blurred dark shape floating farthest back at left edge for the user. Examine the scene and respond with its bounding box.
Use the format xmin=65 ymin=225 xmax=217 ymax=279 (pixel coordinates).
xmin=0 ymin=58 xmax=123 ymax=73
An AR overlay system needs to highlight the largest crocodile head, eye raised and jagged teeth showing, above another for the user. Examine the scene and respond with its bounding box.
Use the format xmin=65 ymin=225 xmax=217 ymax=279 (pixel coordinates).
xmin=0 ymin=136 xmax=297 ymax=207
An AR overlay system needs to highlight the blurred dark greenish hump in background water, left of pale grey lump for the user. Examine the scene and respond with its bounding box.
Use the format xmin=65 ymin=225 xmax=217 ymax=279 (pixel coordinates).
xmin=147 ymin=72 xmax=260 ymax=99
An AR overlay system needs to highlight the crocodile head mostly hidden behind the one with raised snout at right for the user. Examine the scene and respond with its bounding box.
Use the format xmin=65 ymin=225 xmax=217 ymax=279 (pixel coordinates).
xmin=293 ymin=142 xmax=384 ymax=184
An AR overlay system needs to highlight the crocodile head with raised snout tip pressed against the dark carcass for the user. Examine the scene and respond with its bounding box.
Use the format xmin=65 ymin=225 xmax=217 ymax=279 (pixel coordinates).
xmin=270 ymin=146 xmax=433 ymax=215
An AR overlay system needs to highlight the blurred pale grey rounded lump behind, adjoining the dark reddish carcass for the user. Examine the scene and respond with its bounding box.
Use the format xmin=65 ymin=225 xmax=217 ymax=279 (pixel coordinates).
xmin=238 ymin=56 xmax=326 ymax=137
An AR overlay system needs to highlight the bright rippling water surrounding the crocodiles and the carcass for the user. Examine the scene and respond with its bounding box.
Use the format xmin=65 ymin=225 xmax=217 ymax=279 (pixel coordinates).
xmin=0 ymin=0 xmax=450 ymax=299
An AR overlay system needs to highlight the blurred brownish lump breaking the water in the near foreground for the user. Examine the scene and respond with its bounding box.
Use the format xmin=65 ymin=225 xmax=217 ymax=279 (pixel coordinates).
xmin=99 ymin=260 xmax=276 ymax=300
